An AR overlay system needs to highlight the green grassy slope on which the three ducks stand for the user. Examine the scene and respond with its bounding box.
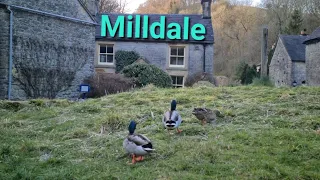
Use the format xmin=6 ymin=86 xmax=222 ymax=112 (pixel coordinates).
xmin=0 ymin=87 xmax=320 ymax=179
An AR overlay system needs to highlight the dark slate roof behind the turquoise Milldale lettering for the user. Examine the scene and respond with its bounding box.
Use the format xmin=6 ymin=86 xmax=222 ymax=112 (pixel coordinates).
xmin=96 ymin=13 xmax=214 ymax=44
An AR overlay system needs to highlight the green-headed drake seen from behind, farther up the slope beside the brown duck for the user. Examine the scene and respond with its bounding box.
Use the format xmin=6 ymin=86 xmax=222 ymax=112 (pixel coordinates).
xmin=162 ymin=100 xmax=182 ymax=133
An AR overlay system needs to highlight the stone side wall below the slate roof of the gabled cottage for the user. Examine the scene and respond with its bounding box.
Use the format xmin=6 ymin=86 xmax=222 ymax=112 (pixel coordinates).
xmin=291 ymin=61 xmax=306 ymax=86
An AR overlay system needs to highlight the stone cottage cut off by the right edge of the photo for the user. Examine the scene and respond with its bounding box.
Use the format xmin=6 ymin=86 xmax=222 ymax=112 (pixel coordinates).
xmin=304 ymin=27 xmax=320 ymax=86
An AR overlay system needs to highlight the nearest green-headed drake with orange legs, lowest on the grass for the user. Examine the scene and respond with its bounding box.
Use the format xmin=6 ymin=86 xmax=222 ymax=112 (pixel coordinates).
xmin=123 ymin=121 xmax=155 ymax=164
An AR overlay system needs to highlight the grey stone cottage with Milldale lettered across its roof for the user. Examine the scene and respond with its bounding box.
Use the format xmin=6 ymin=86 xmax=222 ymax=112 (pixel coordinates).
xmin=95 ymin=0 xmax=214 ymax=87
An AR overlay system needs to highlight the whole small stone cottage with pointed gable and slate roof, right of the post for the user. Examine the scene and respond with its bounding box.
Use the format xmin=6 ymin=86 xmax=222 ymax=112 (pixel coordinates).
xmin=269 ymin=35 xmax=306 ymax=87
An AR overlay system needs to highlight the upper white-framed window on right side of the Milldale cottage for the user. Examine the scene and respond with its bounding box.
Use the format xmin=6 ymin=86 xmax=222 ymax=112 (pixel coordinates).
xmin=169 ymin=46 xmax=185 ymax=67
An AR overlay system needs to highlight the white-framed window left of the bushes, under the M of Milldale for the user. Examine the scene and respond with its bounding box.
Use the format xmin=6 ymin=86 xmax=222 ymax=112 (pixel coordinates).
xmin=99 ymin=44 xmax=114 ymax=65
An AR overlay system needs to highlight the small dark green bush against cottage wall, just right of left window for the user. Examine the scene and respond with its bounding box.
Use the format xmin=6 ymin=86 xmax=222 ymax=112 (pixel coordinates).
xmin=115 ymin=51 xmax=140 ymax=72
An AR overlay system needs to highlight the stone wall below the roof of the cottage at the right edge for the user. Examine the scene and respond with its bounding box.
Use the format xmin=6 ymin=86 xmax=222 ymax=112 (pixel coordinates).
xmin=306 ymin=42 xmax=320 ymax=86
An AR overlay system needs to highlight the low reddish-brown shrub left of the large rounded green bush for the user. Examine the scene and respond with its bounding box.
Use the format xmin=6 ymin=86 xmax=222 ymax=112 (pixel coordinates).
xmin=84 ymin=73 xmax=134 ymax=98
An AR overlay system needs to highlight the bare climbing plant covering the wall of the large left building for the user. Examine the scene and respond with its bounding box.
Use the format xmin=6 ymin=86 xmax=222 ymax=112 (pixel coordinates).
xmin=12 ymin=37 xmax=91 ymax=99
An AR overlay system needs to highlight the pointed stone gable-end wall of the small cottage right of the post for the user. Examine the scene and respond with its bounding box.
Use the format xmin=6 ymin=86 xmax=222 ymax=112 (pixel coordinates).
xmin=269 ymin=38 xmax=292 ymax=87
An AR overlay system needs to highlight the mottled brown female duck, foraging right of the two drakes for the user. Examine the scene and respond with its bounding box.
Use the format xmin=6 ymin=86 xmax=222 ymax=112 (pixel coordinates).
xmin=192 ymin=108 xmax=220 ymax=125
